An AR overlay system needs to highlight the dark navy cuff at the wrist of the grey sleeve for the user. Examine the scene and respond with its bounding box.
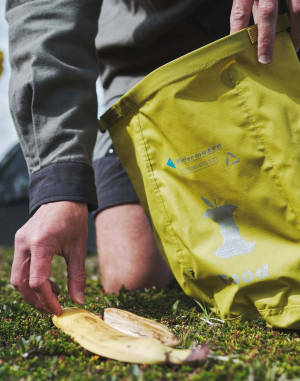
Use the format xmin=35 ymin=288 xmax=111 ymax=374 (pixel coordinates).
xmin=29 ymin=162 xmax=98 ymax=215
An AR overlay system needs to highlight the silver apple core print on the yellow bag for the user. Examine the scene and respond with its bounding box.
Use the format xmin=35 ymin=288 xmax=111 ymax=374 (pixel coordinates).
xmin=202 ymin=197 xmax=256 ymax=258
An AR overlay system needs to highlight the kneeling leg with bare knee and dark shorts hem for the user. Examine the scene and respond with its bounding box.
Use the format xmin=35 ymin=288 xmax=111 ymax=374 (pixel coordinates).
xmin=93 ymin=141 xmax=172 ymax=293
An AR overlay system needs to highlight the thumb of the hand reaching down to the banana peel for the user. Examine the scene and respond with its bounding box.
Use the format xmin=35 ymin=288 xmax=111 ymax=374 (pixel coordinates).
xmin=67 ymin=245 xmax=86 ymax=304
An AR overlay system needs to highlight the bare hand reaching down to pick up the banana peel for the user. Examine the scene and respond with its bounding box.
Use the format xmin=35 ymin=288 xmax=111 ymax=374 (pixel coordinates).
xmin=11 ymin=201 xmax=88 ymax=315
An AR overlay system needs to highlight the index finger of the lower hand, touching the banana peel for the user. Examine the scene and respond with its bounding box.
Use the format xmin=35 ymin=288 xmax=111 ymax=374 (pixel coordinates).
xmin=29 ymin=244 xmax=62 ymax=315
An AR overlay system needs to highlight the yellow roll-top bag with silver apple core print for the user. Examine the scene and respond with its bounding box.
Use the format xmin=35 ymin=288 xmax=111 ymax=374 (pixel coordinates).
xmin=100 ymin=16 xmax=300 ymax=328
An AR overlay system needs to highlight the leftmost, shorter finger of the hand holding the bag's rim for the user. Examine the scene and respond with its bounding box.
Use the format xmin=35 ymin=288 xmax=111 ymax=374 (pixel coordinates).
xmin=230 ymin=0 xmax=254 ymax=33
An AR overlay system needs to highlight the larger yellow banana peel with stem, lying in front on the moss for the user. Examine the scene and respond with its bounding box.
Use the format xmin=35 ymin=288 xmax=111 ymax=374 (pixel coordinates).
xmin=52 ymin=308 xmax=209 ymax=364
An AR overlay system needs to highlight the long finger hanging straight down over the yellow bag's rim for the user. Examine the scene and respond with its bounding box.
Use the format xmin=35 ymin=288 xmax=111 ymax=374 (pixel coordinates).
xmin=257 ymin=0 xmax=278 ymax=64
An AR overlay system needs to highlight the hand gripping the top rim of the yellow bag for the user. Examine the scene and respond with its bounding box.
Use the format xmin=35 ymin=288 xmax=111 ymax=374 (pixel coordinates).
xmin=230 ymin=0 xmax=300 ymax=64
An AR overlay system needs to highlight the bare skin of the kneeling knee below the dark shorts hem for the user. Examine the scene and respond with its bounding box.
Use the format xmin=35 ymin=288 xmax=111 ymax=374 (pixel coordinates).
xmin=96 ymin=204 xmax=172 ymax=293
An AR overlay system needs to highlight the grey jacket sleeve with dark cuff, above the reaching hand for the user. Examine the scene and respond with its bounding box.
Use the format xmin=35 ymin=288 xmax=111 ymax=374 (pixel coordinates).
xmin=6 ymin=0 xmax=102 ymax=214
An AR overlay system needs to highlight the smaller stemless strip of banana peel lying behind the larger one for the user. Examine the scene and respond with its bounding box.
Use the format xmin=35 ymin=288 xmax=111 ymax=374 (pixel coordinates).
xmin=104 ymin=308 xmax=180 ymax=347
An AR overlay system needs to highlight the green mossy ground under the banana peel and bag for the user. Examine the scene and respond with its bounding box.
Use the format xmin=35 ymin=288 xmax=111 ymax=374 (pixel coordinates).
xmin=0 ymin=248 xmax=300 ymax=381
